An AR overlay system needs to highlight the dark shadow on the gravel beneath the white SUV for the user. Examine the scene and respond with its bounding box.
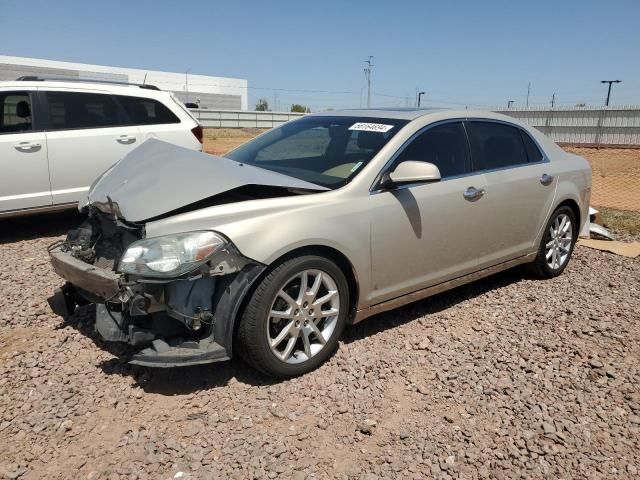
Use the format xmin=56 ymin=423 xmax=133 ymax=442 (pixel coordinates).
xmin=0 ymin=209 xmax=84 ymax=245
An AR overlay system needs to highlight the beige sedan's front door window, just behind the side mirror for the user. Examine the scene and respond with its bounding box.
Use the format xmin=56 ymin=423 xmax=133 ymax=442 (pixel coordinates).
xmin=394 ymin=122 xmax=471 ymax=178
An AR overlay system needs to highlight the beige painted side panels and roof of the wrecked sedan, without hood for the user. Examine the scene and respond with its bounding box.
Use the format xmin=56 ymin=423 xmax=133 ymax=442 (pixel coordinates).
xmin=146 ymin=110 xmax=591 ymax=316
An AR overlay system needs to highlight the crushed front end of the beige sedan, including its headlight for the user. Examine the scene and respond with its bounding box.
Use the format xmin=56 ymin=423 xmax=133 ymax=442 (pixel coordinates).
xmin=49 ymin=207 xmax=265 ymax=367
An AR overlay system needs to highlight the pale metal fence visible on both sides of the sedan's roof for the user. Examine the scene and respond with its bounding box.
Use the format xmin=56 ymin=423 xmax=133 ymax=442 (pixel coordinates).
xmin=192 ymin=106 xmax=640 ymax=146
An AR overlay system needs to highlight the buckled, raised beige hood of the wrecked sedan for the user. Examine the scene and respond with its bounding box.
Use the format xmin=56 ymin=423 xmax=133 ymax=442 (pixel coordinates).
xmin=88 ymin=139 xmax=328 ymax=222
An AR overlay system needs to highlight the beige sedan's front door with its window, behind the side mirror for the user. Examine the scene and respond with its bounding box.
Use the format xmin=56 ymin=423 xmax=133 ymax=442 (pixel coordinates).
xmin=369 ymin=122 xmax=486 ymax=303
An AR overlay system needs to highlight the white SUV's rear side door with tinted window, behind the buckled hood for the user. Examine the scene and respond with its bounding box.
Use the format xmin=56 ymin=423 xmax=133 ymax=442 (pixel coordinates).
xmin=40 ymin=89 xmax=141 ymax=204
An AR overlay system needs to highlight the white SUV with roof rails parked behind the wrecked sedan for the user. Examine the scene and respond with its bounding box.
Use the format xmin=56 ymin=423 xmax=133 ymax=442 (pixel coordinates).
xmin=0 ymin=77 xmax=202 ymax=217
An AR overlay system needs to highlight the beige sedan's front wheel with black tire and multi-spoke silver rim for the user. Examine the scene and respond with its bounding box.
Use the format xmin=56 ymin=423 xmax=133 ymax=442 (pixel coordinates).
xmin=236 ymin=255 xmax=349 ymax=378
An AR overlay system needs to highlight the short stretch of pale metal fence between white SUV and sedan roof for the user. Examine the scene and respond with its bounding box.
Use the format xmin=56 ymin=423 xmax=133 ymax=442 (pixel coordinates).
xmin=191 ymin=109 xmax=304 ymax=128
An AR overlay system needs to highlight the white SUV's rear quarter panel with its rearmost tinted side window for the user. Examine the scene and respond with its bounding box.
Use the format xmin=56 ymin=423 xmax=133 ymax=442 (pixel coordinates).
xmin=117 ymin=95 xmax=202 ymax=150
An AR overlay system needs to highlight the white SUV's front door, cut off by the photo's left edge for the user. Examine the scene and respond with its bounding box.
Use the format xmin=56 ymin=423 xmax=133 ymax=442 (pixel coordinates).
xmin=0 ymin=90 xmax=51 ymax=212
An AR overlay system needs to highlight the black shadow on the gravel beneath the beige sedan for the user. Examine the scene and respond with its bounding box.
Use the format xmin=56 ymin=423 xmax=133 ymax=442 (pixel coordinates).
xmin=59 ymin=269 xmax=527 ymax=396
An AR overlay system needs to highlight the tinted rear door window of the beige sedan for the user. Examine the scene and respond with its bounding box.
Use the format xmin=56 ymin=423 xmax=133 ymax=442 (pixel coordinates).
xmin=466 ymin=122 xmax=527 ymax=170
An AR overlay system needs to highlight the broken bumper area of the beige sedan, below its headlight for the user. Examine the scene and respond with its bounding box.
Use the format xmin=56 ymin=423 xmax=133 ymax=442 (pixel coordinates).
xmin=48 ymin=246 xmax=265 ymax=367
